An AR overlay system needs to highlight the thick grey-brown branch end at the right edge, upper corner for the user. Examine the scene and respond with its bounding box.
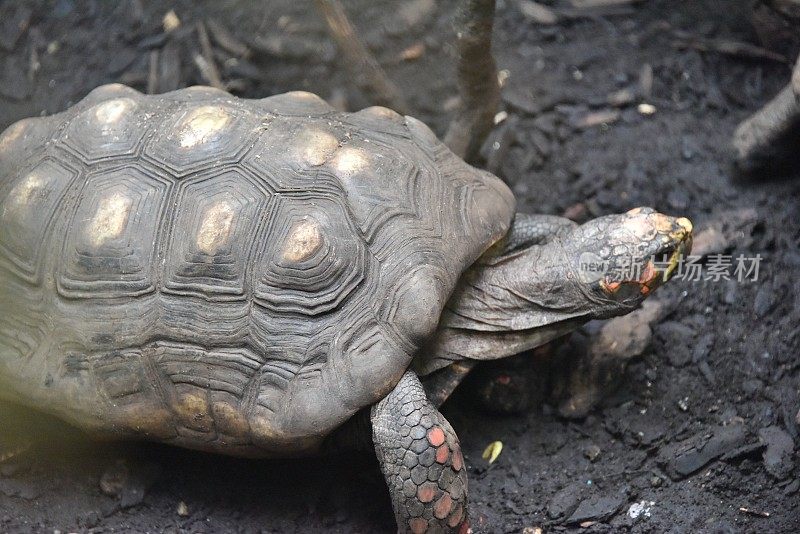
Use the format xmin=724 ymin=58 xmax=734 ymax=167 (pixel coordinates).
xmin=733 ymin=58 xmax=800 ymax=173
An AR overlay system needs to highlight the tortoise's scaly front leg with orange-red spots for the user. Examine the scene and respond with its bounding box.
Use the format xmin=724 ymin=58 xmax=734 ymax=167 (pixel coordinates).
xmin=371 ymin=371 xmax=468 ymax=534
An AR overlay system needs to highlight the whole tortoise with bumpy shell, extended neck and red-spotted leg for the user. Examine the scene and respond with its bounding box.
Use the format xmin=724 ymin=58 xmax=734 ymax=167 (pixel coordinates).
xmin=0 ymin=84 xmax=691 ymax=532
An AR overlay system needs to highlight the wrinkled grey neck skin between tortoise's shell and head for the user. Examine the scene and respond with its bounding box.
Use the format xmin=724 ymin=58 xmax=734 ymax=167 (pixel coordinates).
xmin=419 ymin=239 xmax=599 ymax=372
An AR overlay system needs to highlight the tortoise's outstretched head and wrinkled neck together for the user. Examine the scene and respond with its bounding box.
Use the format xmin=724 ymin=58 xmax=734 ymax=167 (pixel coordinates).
xmin=413 ymin=208 xmax=692 ymax=376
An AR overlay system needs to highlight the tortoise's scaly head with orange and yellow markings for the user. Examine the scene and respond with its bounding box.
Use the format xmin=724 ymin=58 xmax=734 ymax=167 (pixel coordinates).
xmin=563 ymin=208 xmax=692 ymax=317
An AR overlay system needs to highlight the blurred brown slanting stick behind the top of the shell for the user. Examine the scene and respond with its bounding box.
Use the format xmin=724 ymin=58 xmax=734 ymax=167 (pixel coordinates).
xmin=314 ymin=0 xmax=408 ymax=113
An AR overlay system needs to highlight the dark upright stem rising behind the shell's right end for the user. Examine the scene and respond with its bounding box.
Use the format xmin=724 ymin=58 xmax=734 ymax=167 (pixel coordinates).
xmin=444 ymin=0 xmax=500 ymax=159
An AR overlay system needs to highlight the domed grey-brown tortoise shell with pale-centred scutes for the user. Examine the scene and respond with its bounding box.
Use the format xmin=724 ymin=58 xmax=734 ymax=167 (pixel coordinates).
xmin=0 ymin=85 xmax=514 ymax=456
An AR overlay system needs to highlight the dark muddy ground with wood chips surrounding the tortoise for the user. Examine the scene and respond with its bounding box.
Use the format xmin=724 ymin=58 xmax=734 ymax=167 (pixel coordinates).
xmin=0 ymin=0 xmax=800 ymax=533
